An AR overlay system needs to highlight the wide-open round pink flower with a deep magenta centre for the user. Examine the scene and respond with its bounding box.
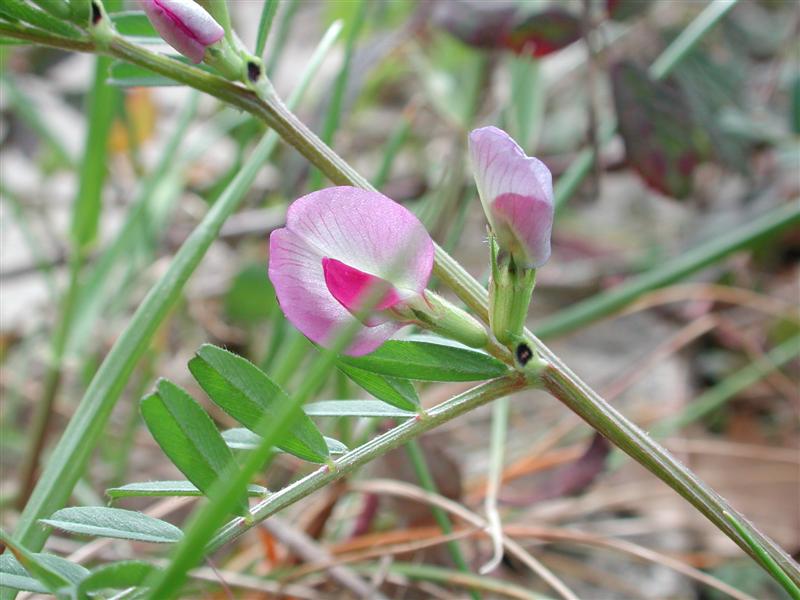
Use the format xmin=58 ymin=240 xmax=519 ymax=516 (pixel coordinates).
xmin=269 ymin=187 xmax=433 ymax=356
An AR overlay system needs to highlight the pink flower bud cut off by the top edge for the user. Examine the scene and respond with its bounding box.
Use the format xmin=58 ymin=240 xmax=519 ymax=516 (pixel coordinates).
xmin=139 ymin=0 xmax=225 ymax=64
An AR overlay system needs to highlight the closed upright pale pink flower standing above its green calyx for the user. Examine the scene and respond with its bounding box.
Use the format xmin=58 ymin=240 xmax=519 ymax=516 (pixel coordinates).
xmin=469 ymin=127 xmax=553 ymax=268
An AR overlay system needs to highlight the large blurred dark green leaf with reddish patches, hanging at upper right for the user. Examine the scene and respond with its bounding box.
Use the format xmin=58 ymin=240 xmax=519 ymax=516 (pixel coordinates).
xmin=611 ymin=63 xmax=708 ymax=198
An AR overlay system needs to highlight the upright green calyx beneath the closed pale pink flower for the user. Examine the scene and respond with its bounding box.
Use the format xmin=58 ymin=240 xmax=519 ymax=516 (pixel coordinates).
xmin=489 ymin=235 xmax=536 ymax=351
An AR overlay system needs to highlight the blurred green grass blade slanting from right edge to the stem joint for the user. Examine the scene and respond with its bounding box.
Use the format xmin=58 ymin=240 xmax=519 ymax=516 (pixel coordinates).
xmin=534 ymin=200 xmax=800 ymax=339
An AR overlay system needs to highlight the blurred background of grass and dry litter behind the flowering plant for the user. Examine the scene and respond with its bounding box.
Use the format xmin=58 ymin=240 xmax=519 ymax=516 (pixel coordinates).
xmin=0 ymin=0 xmax=800 ymax=599
